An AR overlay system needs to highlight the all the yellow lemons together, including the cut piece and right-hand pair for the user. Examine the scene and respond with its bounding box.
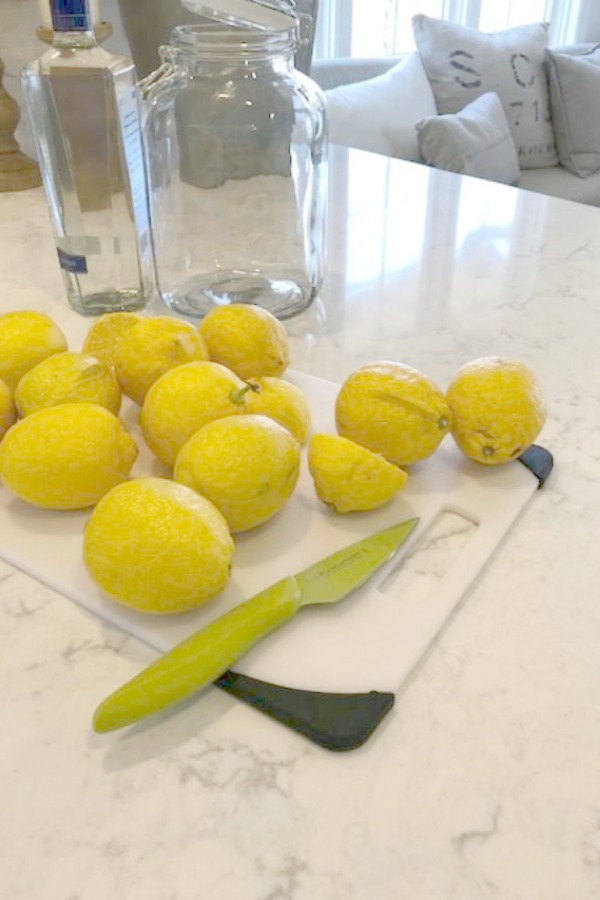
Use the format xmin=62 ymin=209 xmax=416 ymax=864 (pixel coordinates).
xmin=0 ymin=304 xmax=545 ymax=613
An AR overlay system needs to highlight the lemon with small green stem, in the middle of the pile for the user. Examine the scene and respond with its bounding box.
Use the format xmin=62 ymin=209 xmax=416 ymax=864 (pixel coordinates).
xmin=140 ymin=361 xmax=247 ymax=466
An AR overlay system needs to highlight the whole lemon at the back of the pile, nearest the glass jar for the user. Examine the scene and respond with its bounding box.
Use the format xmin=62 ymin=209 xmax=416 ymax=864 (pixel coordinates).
xmin=198 ymin=303 xmax=290 ymax=378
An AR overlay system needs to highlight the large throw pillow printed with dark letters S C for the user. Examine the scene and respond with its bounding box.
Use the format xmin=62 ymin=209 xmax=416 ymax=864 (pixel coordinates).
xmin=412 ymin=15 xmax=558 ymax=169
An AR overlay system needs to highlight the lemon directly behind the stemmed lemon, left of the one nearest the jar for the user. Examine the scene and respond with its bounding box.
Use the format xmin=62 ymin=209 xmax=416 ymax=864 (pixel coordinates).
xmin=113 ymin=316 xmax=208 ymax=404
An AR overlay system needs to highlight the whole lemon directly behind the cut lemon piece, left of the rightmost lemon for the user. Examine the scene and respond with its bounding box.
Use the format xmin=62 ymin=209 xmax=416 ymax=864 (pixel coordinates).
xmin=335 ymin=362 xmax=451 ymax=466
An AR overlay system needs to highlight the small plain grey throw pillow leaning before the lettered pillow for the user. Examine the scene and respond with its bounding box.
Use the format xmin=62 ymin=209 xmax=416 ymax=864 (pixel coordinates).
xmin=417 ymin=93 xmax=520 ymax=184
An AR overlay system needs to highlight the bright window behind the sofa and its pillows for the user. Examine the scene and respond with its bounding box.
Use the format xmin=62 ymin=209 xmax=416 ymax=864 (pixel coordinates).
xmin=315 ymin=0 xmax=600 ymax=59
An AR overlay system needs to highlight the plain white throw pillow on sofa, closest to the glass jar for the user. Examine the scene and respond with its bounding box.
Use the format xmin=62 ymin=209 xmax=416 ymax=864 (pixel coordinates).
xmin=325 ymin=53 xmax=436 ymax=161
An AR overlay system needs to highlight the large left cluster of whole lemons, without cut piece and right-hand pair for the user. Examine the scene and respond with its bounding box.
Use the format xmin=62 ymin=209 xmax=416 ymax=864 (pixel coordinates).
xmin=0 ymin=304 xmax=310 ymax=613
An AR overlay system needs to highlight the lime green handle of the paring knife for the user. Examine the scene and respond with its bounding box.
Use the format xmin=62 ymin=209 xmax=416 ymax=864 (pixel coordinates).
xmin=93 ymin=576 xmax=302 ymax=732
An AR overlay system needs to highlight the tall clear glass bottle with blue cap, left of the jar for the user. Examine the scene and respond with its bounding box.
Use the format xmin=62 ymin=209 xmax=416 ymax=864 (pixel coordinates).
xmin=22 ymin=0 xmax=155 ymax=315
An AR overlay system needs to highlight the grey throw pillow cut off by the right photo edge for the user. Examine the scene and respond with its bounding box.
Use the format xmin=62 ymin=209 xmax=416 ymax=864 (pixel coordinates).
xmin=546 ymin=47 xmax=600 ymax=178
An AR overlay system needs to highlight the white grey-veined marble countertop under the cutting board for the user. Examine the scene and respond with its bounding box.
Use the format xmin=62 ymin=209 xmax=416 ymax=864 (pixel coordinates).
xmin=0 ymin=151 xmax=600 ymax=900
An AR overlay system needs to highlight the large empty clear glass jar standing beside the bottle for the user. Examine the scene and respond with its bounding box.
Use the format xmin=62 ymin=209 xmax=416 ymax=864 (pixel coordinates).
xmin=141 ymin=16 xmax=327 ymax=318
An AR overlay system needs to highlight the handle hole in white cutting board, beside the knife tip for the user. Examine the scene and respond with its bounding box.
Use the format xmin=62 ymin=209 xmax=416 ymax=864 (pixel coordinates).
xmin=379 ymin=509 xmax=479 ymax=603
